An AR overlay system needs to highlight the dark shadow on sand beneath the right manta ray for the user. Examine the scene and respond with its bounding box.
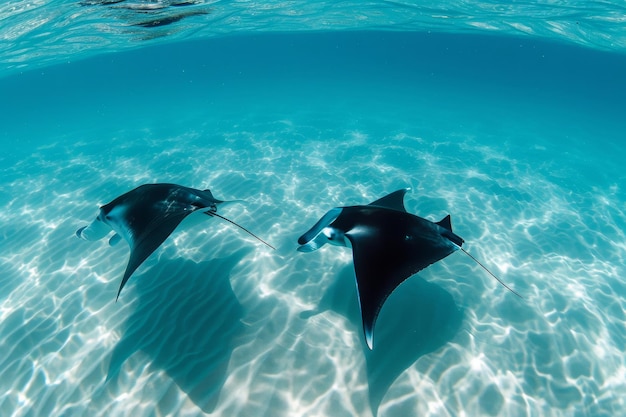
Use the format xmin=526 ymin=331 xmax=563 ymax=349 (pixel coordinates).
xmin=300 ymin=266 xmax=463 ymax=415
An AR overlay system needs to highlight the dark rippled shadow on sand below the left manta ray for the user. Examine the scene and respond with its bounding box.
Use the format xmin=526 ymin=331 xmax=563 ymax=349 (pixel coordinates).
xmin=107 ymin=248 xmax=252 ymax=414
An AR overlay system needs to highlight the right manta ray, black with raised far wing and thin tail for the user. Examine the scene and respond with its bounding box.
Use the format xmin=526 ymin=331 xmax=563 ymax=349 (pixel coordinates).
xmin=298 ymin=189 xmax=521 ymax=350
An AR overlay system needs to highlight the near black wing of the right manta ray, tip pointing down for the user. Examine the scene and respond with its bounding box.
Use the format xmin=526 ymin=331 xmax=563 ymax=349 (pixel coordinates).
xmin=337 ymin=206 xmax=458 ymax=349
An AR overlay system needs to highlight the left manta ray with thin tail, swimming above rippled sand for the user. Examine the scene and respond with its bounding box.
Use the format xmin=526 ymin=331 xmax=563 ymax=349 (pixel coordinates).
xmin=76 ymin=184 xmax=275 ymax=301
